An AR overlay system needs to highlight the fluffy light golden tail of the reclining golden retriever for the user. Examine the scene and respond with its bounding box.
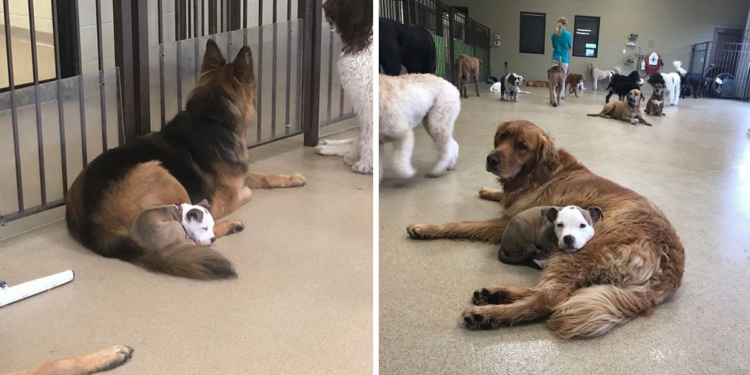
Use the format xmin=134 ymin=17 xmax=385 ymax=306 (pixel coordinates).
xmin=547 ymin=285 xmax=652 ymax=339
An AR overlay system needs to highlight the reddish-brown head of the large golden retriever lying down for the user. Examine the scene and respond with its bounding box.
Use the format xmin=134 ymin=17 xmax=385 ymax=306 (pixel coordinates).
xmin=485 ymin=120 xmax=557 ymax=183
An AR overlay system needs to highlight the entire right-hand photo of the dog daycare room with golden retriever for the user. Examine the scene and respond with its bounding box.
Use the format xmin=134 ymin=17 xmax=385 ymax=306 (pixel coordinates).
xmin=378 ymin=0 xmax=750 ymax=375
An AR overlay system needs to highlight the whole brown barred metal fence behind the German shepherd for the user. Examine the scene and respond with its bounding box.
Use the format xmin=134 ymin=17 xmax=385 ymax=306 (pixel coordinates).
xmin=0 ymin=0 xmax=354 ymax=228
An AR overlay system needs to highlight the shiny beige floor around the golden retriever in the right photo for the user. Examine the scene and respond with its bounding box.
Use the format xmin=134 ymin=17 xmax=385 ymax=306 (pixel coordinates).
xmin=379 ymin=85 xmax=750 ymax=375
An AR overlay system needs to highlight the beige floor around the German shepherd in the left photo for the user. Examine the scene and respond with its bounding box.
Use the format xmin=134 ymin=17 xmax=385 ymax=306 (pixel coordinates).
xmin=0 ymin=132 xmax=373 ymax=375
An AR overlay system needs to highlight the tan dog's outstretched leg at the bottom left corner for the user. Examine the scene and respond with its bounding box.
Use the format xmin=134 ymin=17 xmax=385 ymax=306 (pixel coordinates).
xmin=5 ymin=345 xmax=133 ymax=375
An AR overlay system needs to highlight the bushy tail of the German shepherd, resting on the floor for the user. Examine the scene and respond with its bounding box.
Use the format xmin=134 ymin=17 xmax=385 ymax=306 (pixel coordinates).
xmin=114 ymin=238 xmax=237 ymax=280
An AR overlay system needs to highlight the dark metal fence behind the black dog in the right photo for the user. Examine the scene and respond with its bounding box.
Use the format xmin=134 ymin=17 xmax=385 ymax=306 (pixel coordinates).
xmin=380 ymin=0 xmax=491 ymax=82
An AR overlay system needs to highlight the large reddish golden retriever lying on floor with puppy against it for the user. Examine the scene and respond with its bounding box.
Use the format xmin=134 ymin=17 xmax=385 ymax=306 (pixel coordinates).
xmin=407 ymin=120 xmax=685 ymax=338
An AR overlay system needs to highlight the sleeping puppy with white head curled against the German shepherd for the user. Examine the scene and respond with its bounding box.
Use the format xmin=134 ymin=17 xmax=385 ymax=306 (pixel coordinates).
xmin=130 ymin=200 xmax=216 ymax=251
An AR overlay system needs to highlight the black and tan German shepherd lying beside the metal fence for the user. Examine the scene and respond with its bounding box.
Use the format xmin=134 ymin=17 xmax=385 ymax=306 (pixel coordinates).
xmin=65 ymin=40 xmax=305 ymax=279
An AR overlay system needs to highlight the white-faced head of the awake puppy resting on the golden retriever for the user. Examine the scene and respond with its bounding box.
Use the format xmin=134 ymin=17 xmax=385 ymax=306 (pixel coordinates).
xmin=542 ymin=206 xmax=604 ymax=253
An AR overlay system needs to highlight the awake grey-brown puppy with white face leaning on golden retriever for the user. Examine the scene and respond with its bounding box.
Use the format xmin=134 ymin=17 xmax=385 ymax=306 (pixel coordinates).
xmin=497 ymin=206 xmax=604 ymax=270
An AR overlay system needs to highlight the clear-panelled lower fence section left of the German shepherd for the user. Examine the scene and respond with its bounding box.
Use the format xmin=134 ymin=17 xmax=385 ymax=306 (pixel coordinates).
xmin=0 ymin=68 xmax=123 ymax=224
